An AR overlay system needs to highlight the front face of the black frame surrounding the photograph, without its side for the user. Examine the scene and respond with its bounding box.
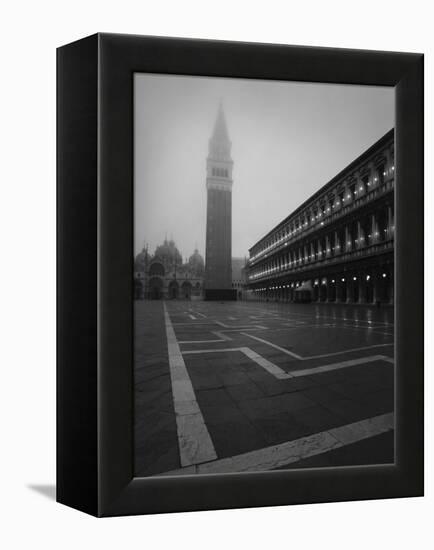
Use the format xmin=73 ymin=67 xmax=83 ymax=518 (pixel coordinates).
xmin=94 ymin=35 xmax=423 ymax=516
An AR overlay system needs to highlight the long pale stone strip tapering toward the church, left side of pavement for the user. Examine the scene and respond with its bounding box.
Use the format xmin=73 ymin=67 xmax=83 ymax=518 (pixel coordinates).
xmin=163 ymin=304 xmax=217 ymax=466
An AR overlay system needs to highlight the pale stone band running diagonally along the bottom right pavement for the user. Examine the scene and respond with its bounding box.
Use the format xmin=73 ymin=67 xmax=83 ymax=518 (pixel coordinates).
xmin=159 ymin=413 xmax=394 ymax=476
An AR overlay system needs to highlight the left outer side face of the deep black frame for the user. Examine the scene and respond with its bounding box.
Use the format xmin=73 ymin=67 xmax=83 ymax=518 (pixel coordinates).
xmin=56 ymin=35 xmax=98 ymax=515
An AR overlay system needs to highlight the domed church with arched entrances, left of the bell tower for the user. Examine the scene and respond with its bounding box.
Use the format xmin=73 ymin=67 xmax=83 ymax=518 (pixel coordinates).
xmin=134 ymin=239 xmax=205 ymax=300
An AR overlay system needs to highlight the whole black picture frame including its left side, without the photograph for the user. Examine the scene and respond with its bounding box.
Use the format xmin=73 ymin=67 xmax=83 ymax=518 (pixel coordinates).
xmin=57 ymin=34 xmax=424 ymax=516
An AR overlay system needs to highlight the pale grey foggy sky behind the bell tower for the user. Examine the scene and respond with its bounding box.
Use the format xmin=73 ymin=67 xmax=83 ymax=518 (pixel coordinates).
xmin=134 ymin=74 xmax=394 ymax=258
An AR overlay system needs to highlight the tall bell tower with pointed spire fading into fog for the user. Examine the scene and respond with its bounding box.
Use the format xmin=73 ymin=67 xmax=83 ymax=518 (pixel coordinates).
xmin=205 ymin=103 xmax=236 ymax=300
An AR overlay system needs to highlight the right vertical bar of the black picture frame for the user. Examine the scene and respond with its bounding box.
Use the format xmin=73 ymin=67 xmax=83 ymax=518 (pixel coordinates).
xmin=395 ymin=55 xmax=424 ymax=496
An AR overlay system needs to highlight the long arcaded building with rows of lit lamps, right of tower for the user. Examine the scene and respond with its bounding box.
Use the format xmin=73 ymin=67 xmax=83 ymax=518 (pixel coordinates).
xmin=246 ymin=130 xmax=395 ymax=304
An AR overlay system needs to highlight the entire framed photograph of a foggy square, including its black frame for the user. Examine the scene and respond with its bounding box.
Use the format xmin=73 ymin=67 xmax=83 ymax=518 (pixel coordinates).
xmin=57 ymin=34 xmax=423 ymax=516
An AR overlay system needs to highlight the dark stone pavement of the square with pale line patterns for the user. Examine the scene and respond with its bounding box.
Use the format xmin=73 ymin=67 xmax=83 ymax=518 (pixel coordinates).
xmin=134 ymin=301 xmax=394 ymax=476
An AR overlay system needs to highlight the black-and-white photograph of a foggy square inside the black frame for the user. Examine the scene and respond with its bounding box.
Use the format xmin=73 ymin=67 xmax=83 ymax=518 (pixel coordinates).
xmin=132 ymin=73 xmax=399 ymax=477
